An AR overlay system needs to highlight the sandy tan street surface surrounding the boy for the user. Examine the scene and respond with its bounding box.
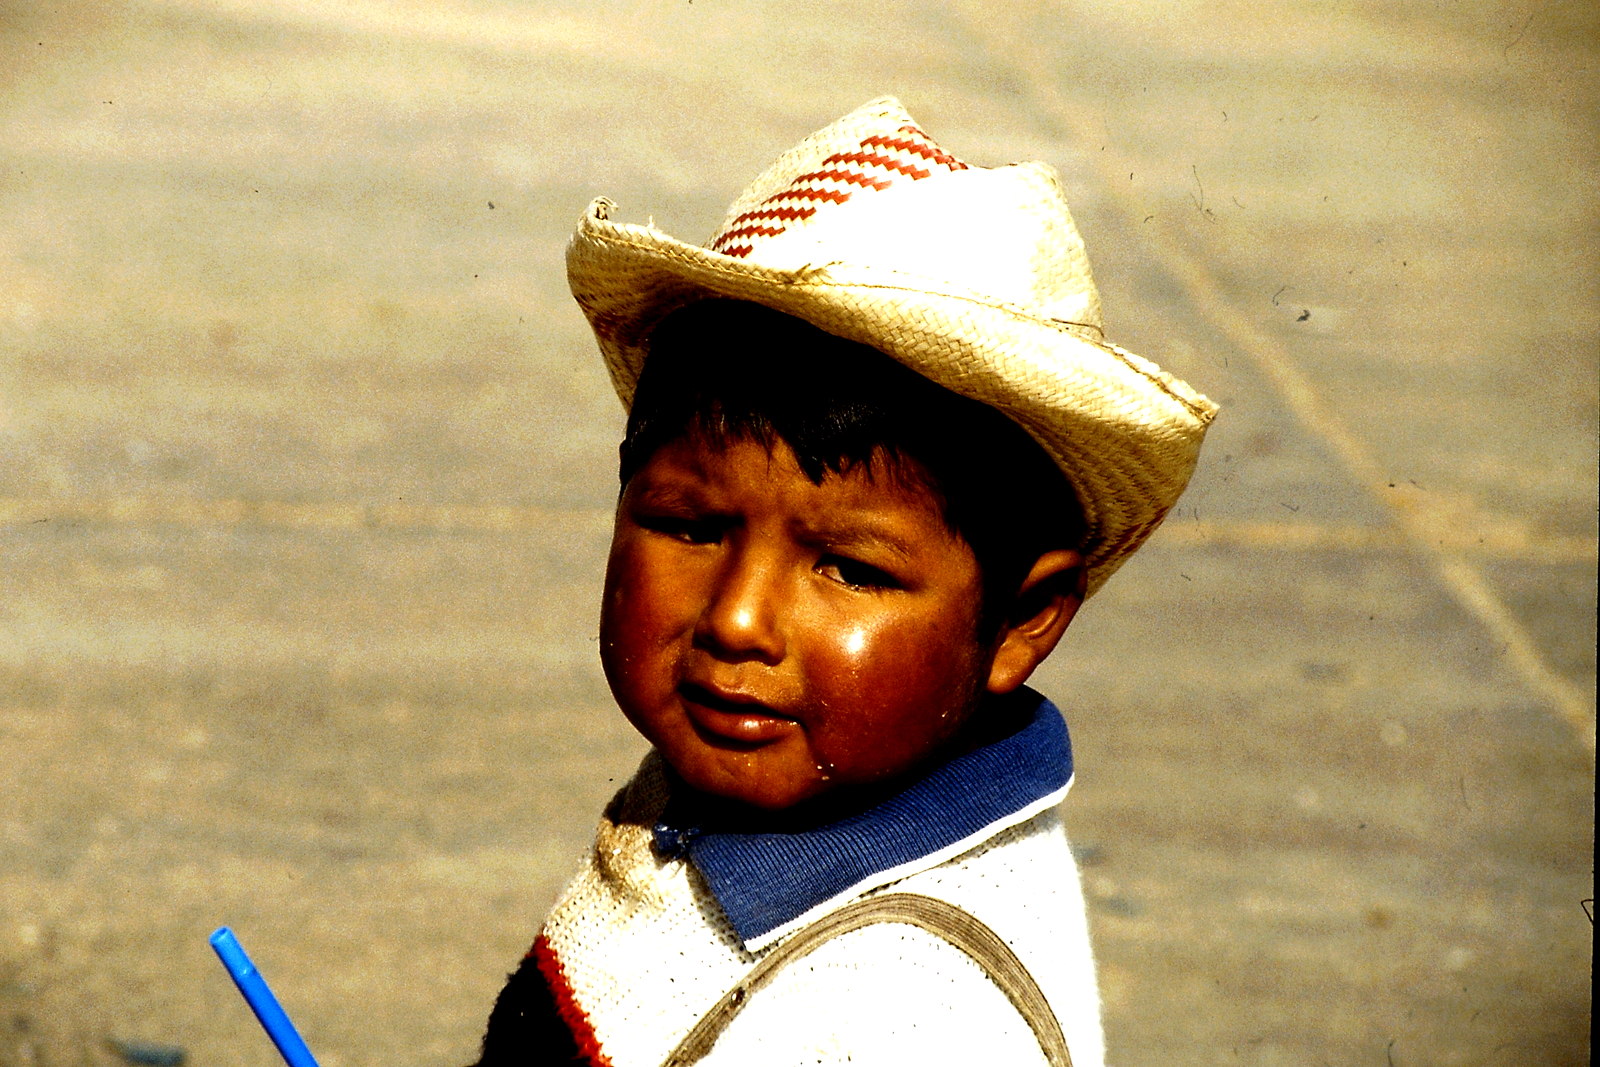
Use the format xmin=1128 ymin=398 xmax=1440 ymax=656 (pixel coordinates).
xmin=0 ymin=0 xmax=1600 ymax=1067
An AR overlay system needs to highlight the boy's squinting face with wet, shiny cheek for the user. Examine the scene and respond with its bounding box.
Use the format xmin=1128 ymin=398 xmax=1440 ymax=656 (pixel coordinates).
xmin=600 ymin=435 xmax=992 ymax=809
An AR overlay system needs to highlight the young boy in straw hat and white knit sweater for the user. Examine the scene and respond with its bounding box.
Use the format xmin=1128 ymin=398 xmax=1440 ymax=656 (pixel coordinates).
xmin=482 ymin=99 xmax=1214 ymax=1067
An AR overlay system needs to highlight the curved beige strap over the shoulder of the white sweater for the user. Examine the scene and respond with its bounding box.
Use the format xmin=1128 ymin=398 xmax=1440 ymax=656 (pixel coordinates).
xmin=662 ymin=893 xmax=1072 ymax=1067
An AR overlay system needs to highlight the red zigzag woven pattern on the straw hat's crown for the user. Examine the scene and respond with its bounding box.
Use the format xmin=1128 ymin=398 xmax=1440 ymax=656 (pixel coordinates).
xmin=709 ymin=123 xmax=966 ymax=259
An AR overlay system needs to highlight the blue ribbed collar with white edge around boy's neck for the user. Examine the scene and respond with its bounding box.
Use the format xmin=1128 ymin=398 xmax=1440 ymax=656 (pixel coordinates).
xmin=654 ymin=689 xmax=1072 ymax=952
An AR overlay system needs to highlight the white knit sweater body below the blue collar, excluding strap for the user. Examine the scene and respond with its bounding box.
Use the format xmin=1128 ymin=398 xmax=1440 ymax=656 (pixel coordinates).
xmin=534 ymin=709 xmax=1104 ymax=1067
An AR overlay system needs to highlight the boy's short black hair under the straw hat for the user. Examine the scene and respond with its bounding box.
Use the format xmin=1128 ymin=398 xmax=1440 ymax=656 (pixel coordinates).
xmin=621 ymin=301 xmax=1085 ymax=632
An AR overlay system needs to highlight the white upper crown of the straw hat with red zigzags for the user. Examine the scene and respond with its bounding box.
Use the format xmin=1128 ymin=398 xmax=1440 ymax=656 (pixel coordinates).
xmin=706 ymin=98 xmax=1101 ymax=336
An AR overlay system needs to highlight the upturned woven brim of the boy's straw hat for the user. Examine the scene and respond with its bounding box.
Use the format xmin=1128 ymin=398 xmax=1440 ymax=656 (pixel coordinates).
xmin=566 ymin=200 xmax=1216 ymax=593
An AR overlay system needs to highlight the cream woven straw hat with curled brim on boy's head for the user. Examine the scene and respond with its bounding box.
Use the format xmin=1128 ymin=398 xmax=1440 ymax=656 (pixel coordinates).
xmin=566 ymin=98 xmax=1216 ymax=593
